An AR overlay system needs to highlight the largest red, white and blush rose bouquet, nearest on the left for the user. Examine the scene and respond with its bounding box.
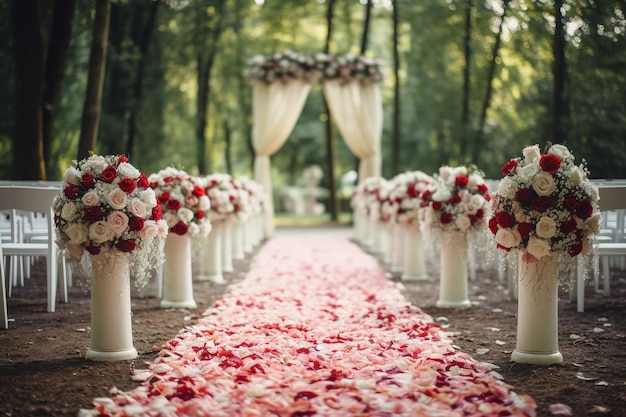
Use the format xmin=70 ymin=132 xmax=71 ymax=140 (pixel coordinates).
xmin=52 ymin=155 xmax=167 ymax=288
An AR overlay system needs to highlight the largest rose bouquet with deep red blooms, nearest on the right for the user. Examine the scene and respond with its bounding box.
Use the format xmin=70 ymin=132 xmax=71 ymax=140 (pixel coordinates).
xmin=489 ymin=141 xmax=601 ymax=262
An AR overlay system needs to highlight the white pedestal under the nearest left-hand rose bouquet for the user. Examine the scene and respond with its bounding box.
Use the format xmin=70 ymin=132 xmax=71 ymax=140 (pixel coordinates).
xmin=85 ymin=254 xmax=137 ymax=362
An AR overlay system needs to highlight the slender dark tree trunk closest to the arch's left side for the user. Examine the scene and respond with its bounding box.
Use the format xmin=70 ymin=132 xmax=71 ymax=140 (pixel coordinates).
xmin=196 ymin=0 xmax=225 ymax=175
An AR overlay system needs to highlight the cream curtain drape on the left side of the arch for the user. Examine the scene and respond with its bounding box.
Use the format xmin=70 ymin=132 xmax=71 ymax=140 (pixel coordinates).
xmin=252 ymin=80 xmax=311 ymax=237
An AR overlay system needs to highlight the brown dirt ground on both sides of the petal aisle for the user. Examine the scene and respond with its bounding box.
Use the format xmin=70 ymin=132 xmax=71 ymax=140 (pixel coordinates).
xmin=0 ymin=224 xmax=626 ymax=417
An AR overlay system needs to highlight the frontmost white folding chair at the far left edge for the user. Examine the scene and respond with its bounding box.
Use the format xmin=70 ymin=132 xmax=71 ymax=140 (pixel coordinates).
xmin=0 ymin=185 xmax=67 ymax=312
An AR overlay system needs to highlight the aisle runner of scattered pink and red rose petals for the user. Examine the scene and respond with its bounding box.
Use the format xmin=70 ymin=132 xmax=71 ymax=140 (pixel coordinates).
xmin=81 ymin=236 xmax=536 ymax=417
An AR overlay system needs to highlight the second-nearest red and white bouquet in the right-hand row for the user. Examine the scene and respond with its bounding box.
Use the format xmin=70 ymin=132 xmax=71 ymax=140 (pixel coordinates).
xmin=421 ymin=166 xmax=491 ymax=232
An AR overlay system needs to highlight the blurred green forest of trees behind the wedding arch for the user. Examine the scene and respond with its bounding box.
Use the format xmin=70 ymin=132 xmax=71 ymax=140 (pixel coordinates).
xmin=0 ymin=0 xmax=626 ymax=216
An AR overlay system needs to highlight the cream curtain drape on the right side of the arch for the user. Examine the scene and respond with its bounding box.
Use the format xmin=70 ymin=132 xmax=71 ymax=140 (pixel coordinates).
xmin=324 ymin=81 xmax=383 ymax=183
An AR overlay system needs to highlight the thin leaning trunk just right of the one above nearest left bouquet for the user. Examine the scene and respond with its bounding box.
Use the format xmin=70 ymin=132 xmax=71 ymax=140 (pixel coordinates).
xmin=126 ymin=1 xmax=160 ymax=156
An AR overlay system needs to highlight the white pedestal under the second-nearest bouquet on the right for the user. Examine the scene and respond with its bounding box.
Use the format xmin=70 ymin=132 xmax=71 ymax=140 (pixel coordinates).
xmin=437 ymin=231 xmax=471 ymax=308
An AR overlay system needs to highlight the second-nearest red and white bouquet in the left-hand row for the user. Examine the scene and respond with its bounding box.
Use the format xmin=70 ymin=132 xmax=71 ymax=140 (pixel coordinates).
xmin=148 ymin=167 xmax=211 ymax=237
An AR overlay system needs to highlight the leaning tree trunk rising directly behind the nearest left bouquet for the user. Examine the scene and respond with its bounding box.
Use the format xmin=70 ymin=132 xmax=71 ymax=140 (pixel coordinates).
xmin=77 ymin=0 xmax=111 ymax=160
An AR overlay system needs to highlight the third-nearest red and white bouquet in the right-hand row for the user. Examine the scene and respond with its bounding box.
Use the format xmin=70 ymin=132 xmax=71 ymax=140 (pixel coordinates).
xmin=389 ymin=171 xmax=434 ymax=225
